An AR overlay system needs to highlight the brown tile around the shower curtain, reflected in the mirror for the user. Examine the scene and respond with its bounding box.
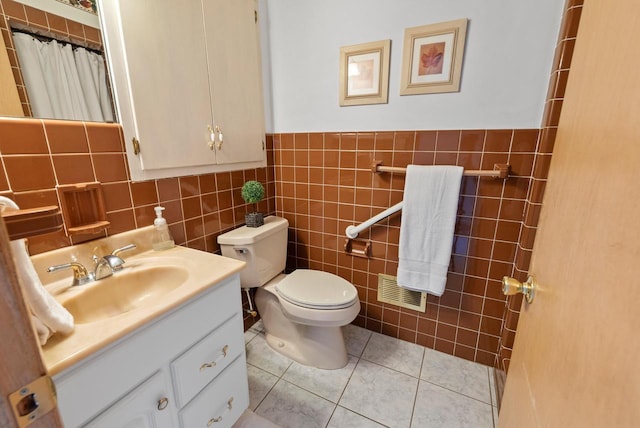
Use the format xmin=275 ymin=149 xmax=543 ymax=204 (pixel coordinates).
xmin=0 ymin=0 xmax=102 ymax=117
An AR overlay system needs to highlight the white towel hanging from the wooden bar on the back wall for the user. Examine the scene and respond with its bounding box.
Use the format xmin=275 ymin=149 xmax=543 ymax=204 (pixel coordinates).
xmin=398 ymin=165 xmax=463 ymax=296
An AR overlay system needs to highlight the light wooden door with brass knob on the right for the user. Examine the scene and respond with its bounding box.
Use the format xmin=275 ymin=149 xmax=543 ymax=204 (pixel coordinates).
xmin=499 ymin=0 xmax=640 ymax=428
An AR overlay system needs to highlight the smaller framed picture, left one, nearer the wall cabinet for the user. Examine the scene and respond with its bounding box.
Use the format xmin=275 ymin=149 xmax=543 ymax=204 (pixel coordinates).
xmin=339 ymin=40 xmax=391 ymax=106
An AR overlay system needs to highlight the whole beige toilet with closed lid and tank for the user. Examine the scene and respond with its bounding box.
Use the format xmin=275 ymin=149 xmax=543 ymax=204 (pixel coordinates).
xmin=218 ymin=216 xmax=360 ymax=369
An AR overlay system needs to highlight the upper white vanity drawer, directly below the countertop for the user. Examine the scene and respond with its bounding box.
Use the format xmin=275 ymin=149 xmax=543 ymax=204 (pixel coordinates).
xmin=171 ymin=314 xmax=244 ymax=407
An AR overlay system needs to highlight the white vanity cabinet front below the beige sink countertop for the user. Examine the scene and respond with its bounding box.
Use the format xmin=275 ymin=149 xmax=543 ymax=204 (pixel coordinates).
xmin=53 ymin=274 xmax=249 ymax=428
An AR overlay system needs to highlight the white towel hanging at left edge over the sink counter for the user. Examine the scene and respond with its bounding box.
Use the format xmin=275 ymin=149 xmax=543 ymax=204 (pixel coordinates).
xmin=0 ymin=196 xmax=74 ymax=345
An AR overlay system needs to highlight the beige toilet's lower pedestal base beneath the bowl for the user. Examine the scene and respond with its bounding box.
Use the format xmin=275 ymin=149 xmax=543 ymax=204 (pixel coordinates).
xmin=255 ymin=286 xmax=355 ymax=370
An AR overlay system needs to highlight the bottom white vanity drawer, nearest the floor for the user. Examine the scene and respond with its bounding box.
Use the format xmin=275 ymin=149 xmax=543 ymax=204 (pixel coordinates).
xmin=179 ymin=354 xmax=249 ymax=428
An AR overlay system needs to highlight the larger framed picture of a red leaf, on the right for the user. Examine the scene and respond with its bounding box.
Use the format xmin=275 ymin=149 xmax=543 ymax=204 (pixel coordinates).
xmin=400 ymin=19 xmax=468 ymax=95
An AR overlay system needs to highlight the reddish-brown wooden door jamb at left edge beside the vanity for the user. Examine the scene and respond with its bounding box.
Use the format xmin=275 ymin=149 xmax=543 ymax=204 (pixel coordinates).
xmin=0 ymin=218 xmax=62 ymax=428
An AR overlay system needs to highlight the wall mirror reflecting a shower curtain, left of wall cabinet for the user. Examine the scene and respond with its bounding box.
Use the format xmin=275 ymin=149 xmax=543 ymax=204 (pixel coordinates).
xmin=0 ymin=0 xmax=115 ymax=122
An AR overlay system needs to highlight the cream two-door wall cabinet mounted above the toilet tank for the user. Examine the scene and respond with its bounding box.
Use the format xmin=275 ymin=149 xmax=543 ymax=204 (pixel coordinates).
xmin=100 ymin=0 xmax=266 ymax=180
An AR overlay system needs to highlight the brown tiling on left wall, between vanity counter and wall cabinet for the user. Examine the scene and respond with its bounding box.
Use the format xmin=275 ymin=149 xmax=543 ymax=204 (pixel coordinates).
xmin=0 ymin=117 xmax=275 ymax=324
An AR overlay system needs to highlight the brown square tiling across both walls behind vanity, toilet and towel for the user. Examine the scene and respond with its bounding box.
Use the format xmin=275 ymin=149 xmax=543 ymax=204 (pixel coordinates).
xmin=0 ymin=118 xmax=540 ymax=364
